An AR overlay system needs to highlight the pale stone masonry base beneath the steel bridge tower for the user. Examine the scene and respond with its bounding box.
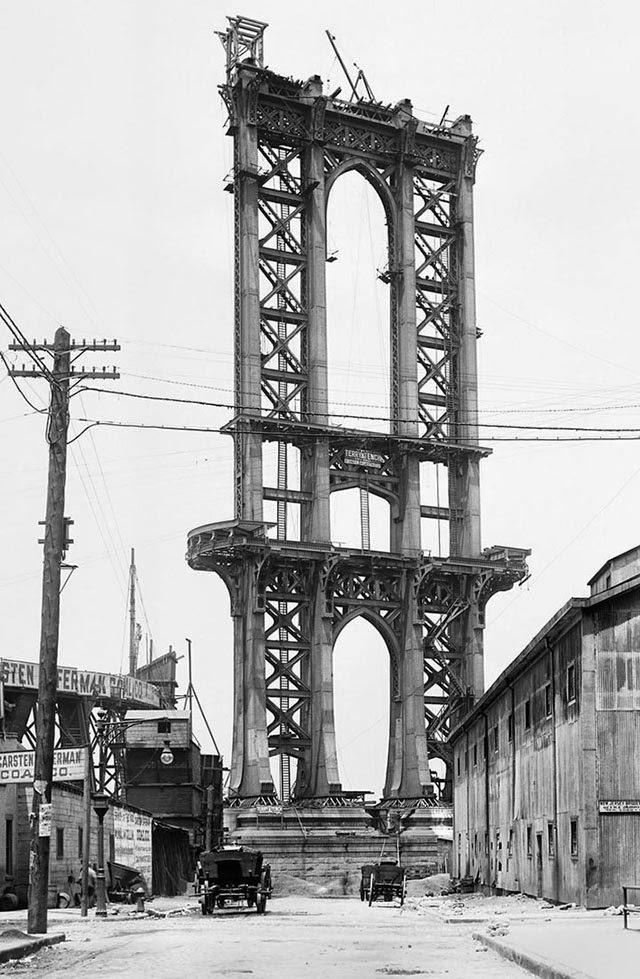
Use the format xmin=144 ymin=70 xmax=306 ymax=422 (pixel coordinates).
xmin=225 ymin=800 xmax=452 ymax=896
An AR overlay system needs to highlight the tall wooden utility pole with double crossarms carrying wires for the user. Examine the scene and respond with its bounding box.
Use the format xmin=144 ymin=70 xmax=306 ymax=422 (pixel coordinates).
xmin=9 ymin=326 xmax=120 ymax=934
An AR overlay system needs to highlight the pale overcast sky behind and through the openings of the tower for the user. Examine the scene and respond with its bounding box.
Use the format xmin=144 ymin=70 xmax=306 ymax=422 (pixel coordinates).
xmin=0 ymin=0 xmax=640 ymax=804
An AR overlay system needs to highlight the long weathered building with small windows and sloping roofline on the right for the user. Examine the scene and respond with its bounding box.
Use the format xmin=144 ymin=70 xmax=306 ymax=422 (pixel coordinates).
xmin=452 ymin=547 xmax=640 ymax=907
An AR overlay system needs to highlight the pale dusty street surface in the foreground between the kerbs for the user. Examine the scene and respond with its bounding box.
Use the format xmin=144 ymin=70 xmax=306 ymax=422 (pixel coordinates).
xmin=0 ymin=897 xmax=529 ymax=979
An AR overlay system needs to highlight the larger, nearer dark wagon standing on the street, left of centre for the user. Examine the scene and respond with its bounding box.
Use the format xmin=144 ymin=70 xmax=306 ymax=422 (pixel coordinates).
xmin=195 ymin=846 xmax=271 ymax=914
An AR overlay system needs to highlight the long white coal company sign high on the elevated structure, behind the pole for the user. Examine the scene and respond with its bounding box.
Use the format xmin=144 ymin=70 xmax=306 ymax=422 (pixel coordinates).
xmin=0 ymin=659 xmax=160 ymax=707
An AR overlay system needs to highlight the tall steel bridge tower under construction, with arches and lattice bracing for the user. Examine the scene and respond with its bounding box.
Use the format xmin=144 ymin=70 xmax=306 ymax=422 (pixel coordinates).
xmin=188 ymin=19 xmax=527 ymax=799
